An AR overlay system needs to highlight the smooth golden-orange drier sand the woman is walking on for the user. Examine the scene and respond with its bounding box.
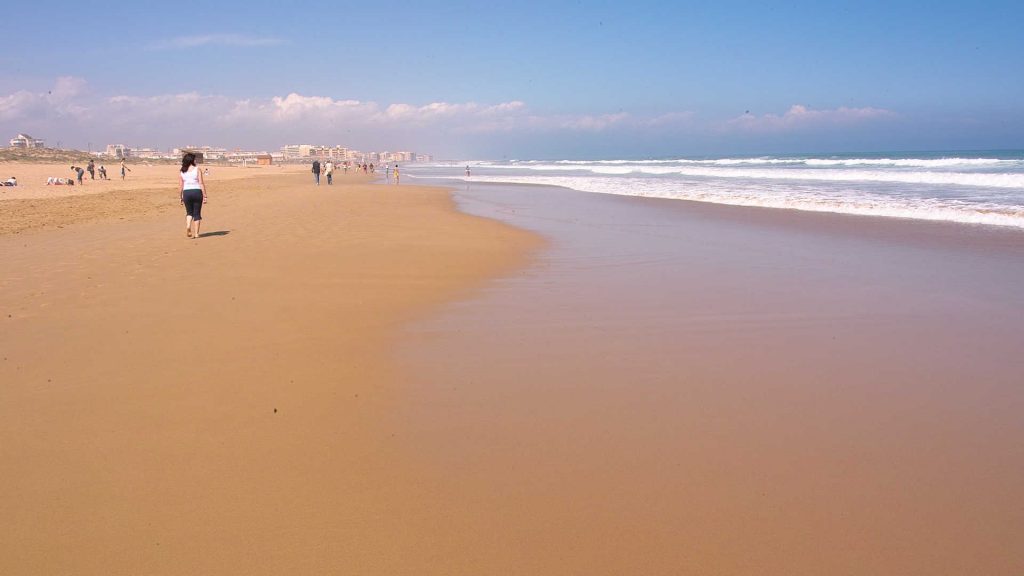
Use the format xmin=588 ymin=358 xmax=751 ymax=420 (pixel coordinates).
xmin=0 ymin=167 xmax=540 ymax=574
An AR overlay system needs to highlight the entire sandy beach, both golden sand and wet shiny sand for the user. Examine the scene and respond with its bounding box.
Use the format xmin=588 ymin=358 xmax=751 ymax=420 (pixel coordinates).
xmin=0 ymin=163 xmax=1024 ymax=576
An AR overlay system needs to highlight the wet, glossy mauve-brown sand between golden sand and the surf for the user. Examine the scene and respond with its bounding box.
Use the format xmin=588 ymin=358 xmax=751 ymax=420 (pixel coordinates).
xmin=395 ymin=184 xmax=1024 ymax=576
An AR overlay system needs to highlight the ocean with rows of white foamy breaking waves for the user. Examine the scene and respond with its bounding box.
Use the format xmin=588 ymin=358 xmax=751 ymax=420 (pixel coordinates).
xmin=406 ymin=151 xmax=1024 ymax=229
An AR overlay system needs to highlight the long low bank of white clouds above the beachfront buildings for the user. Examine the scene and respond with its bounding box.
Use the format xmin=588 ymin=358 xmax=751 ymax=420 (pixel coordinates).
xmin=0 ymin=77 xmax=704 ymax=146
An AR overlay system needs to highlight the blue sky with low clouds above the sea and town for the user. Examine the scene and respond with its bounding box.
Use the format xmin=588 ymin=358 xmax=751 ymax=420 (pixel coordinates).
xmin=0 ymin=1 xmax=1024 ymax=158
